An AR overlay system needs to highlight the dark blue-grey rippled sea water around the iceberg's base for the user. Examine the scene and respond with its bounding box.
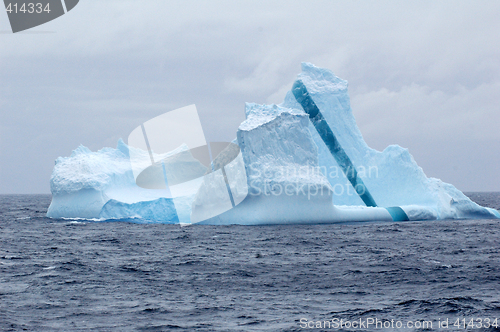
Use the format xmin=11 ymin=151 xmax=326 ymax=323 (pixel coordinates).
xmin=0 ymin=193 xmax=500 ymax=331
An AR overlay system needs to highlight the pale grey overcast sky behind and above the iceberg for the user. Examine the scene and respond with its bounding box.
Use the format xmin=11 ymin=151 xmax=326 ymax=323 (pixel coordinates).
xmin=0 ymin=0 xmax=500 ymax=194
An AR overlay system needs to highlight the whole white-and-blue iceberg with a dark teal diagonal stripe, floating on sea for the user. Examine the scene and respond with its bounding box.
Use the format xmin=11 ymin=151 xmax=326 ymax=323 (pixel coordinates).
xmin=47 ymin=63 xmax=500 ymax=225
